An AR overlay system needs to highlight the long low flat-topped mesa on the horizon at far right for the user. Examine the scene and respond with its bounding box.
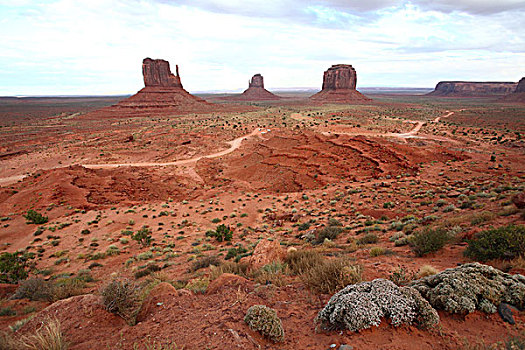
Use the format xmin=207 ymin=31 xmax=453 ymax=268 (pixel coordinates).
xmin=428 ymin=81 xmax=517 ymax=97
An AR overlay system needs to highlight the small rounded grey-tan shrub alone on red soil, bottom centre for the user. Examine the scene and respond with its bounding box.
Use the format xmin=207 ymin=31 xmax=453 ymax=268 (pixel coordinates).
xmin=244 ymin=305 xmax=284 ymax=343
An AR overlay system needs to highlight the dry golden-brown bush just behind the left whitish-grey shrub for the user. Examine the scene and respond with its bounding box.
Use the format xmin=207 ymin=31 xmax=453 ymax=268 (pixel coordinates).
xmin=301 ymin=258 xmax=362 ymax=294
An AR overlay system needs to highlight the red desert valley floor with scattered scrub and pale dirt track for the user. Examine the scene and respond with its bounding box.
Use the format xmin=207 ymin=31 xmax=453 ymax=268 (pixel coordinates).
xmin=0 ymin=95 xmax=525 ymax=349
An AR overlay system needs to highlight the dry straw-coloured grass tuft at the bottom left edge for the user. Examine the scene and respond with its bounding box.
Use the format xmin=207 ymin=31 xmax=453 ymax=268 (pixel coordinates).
xmin=20 ymin=319 xmax=69 ymax=350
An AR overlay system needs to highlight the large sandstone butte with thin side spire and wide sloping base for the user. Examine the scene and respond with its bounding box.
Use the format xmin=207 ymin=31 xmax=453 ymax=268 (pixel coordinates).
xmin=86 ymin=58 xmax=246 ymax=118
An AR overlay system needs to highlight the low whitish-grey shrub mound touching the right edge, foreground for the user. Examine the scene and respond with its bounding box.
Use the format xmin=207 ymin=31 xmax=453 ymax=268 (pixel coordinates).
xmin=410 ymin=263 xmax=525 ymax=314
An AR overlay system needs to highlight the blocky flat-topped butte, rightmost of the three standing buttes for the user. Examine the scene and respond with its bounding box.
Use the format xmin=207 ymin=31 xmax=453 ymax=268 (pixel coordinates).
xmin=310 ymin=64 xmax=370 ymax=103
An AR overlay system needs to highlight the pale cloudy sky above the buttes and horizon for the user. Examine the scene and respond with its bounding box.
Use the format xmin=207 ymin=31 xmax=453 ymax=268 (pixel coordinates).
xmin=0 ymin=0 xmax=525 ymax=96
